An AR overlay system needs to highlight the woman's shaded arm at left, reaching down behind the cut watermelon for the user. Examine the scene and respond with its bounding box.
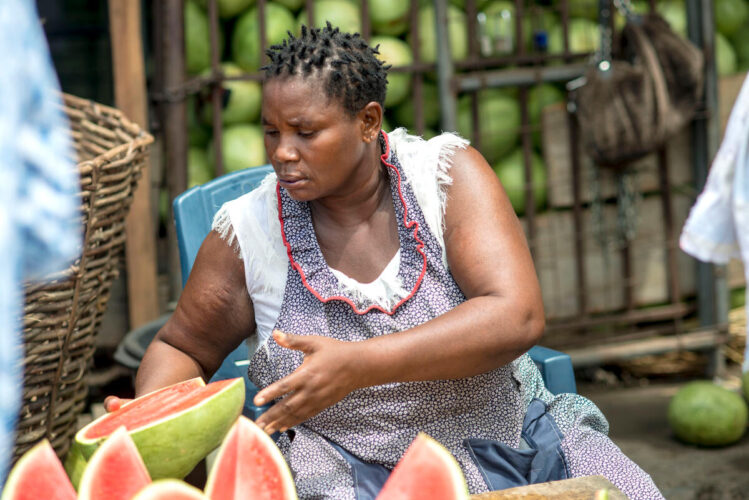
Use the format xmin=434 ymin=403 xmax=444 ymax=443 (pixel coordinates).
xmin=135 ymin=231 xmax=255 ymax=396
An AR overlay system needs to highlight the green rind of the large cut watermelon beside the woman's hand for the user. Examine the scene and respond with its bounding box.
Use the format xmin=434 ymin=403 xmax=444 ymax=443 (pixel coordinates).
xmin=75 ymin=378 xmax=245 ymax=480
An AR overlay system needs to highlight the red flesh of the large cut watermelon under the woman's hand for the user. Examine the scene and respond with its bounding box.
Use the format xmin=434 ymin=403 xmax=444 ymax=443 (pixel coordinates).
xmin=82 ymin=377 xmax=210 ymax=439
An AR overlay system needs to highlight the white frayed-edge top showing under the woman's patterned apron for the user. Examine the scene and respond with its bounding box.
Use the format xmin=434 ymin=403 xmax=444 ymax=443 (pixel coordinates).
xmin=213 ymin=129 xmax=468 ymax=352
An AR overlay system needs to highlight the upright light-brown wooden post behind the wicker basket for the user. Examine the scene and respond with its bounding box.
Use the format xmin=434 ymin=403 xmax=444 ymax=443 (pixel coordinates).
xmin=109 ymin=0 xmax=159 ymax=329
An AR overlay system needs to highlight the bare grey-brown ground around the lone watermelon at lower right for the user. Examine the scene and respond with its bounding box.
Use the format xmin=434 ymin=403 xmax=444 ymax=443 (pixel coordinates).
xmin=578 ymin=373 xmax=749 ymax=500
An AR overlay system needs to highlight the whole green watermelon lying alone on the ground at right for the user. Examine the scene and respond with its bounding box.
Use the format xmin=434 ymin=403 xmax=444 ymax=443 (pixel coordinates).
xmin=668 ymin=380 xmax=747 ymax=446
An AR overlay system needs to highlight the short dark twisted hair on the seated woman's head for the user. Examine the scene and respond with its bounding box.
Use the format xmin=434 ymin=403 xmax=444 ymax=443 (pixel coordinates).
xmin=260 ymin=22 xmax=390 ymax=116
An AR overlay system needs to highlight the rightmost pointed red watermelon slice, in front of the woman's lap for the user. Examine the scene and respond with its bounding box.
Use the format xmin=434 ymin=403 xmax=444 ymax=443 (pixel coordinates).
xmin=375 ymin=433 xmax=468 ymax=500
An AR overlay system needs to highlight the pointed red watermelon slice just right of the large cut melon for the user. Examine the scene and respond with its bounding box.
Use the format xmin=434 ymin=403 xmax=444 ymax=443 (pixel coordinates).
xmin=205 ymin=416 xmax=297 ymax=500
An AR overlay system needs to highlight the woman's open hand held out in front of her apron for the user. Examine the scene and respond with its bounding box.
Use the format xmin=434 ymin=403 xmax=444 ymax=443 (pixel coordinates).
xmin=254 ymin=330 xmax=361 ymax=434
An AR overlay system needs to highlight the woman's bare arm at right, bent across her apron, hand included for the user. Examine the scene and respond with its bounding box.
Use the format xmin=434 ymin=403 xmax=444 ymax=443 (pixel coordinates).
xmin=255 ymin=147 xmax=545 ymax=432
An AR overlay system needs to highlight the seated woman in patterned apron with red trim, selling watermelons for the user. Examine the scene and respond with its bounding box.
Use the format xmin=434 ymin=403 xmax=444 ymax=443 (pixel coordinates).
xmin=121 ymin=25 xmax=660 ymax=499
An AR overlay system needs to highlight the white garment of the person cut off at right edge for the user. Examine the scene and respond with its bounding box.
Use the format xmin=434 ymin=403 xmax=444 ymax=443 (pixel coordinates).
xmin=679 ymin=72 xmax=749 ymax=372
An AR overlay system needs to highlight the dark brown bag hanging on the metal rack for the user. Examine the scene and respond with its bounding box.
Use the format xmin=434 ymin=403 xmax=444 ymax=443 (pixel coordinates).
xmin=572 ymin=0 xmax=704 ymax=168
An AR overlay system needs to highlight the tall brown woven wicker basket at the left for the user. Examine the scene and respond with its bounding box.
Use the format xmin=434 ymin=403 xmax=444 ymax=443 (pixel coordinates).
xmin=13 ymin=95 xmax=153 ymax=462
